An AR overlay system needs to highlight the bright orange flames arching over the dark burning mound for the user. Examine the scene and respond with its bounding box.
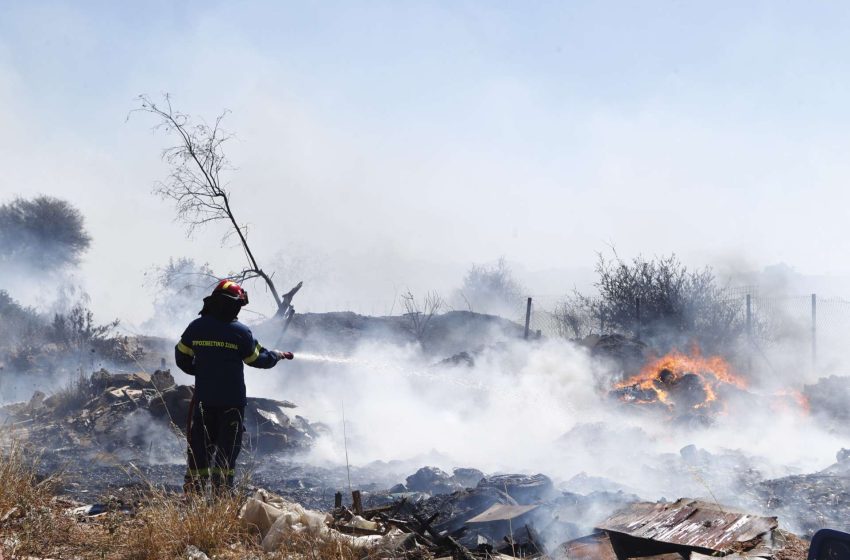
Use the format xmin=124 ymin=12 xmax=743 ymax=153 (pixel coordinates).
xmin=616 ymin=347 xmax=747 ymax=408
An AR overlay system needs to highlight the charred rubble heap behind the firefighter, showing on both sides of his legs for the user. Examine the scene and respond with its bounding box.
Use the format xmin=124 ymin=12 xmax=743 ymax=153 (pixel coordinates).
xmin=0 ymin=369 xmax=326 ymax=461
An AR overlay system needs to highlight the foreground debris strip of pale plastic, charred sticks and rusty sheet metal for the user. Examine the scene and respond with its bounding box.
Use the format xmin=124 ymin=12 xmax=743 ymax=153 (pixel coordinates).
xmin=262 ymin=486 xmax=808 ymax=560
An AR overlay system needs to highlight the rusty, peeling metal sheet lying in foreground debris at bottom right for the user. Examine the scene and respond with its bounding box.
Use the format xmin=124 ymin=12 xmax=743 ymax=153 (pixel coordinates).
xmin=599 ymin=499 xmax=777 ymax=554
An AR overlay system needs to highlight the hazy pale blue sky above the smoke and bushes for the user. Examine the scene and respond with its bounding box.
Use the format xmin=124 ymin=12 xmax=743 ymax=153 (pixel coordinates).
xmin=0 ymin=1 xmax=850 ymax=320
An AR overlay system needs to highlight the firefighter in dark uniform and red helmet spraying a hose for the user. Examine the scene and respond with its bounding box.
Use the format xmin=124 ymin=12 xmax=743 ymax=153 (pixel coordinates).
xmin=174 ymin=280 xmax=293 ymax=491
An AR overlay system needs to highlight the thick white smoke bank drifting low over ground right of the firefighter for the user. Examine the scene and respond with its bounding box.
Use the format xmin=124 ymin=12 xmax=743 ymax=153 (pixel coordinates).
xmin=243 ymin=332 xmax=843 ymax=504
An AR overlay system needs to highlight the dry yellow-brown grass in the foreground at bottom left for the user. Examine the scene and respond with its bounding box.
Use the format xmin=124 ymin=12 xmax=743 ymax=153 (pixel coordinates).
xmin=0 ymin=443 xmax=378 ymax=560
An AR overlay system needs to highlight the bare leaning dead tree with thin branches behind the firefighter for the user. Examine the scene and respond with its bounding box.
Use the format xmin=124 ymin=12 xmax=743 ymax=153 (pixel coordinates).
xmin=137 ymin=94 xmax=303 ymax=329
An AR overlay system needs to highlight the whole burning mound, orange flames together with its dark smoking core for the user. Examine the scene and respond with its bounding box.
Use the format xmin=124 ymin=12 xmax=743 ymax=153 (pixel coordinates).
xmin=614 ymin=348 xmax=747 ymax=410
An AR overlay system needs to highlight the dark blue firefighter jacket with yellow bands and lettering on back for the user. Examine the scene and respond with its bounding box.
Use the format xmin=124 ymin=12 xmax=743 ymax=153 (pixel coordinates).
xmin=174 ymin=315 xmax=279 ymax=406
